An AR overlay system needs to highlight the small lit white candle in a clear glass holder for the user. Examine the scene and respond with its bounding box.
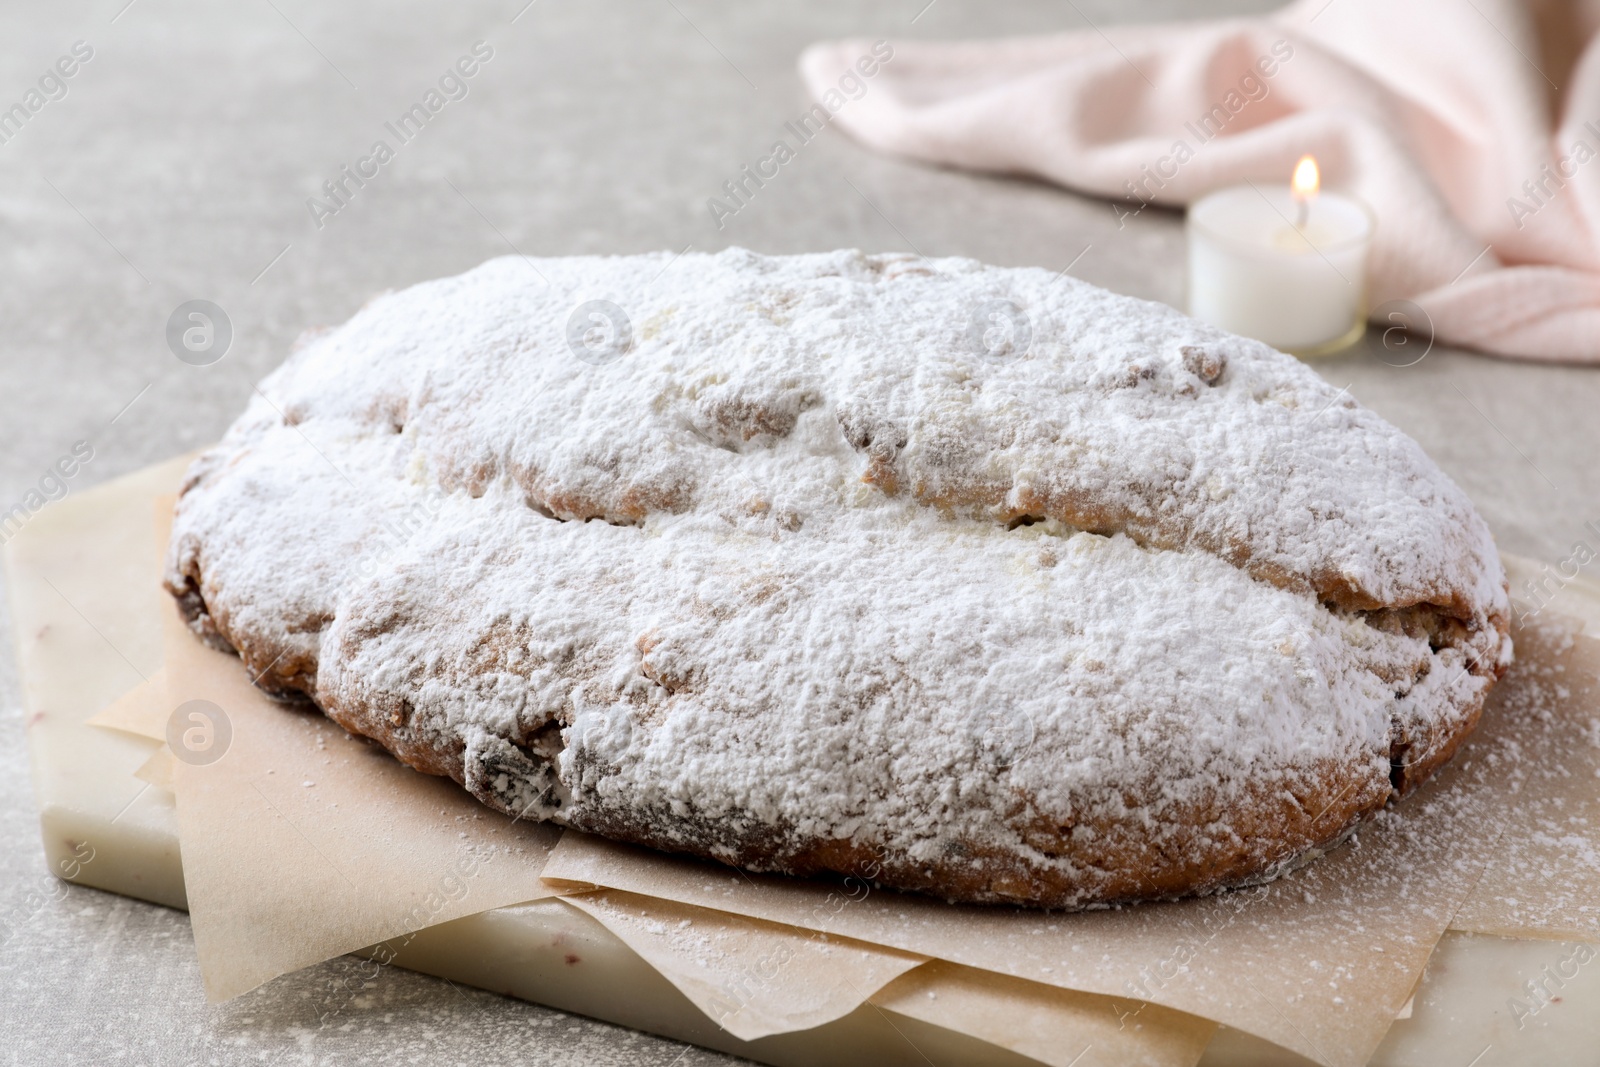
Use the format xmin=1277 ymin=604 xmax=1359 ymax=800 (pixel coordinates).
xmin=1189 ymin=155 xmax=1374 ymax=355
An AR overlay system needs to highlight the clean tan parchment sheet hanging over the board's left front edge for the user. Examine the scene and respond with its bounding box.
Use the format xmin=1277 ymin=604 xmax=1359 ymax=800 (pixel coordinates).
xmin=155 ymin=499 xmax=558 ymax=1000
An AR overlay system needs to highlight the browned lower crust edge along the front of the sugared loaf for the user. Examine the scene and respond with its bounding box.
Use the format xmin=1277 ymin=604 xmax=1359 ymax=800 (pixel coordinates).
xmin=166 ymin=543 xmax=1506 ymax=909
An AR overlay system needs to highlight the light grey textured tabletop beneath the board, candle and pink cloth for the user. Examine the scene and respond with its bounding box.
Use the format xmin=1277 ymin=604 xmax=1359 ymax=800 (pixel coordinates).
xmin=0 ymin=0 xmax=1600 ymax=1067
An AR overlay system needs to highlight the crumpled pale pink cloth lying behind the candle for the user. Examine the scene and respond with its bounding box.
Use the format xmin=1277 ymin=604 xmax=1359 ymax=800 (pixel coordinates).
xmin=800 ymin=0 xmax=1600 ymax=363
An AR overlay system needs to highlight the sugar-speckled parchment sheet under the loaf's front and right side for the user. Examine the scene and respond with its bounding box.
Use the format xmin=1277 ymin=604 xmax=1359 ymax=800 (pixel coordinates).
xmin=544 ymin=617 xmax=1592 ymax=1065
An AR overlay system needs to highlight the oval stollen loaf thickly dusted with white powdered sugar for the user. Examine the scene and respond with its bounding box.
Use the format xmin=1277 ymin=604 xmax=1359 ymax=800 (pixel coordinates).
xmin=168 ymin=250 xmax=1510 ymax=904
